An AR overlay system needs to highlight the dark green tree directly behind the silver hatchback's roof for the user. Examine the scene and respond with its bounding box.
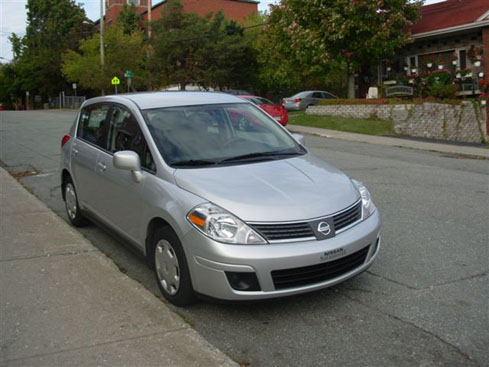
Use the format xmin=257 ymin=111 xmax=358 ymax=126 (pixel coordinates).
xmin=151 ymin=0 xmax=256 ymax=89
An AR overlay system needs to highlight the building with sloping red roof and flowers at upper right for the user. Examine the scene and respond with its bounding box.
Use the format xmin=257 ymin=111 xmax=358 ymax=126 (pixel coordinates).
xmin=379 ymin=0 xmax=489 ymax=95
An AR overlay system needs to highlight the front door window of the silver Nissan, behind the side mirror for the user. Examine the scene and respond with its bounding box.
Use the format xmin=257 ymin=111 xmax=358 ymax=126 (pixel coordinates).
xmin=107 ymin=106 xmax=156 ymax=171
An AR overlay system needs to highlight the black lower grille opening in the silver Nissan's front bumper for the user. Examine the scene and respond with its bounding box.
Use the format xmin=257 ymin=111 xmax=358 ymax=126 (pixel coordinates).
xmin=272 ymin=246 xmax=370 ymax=290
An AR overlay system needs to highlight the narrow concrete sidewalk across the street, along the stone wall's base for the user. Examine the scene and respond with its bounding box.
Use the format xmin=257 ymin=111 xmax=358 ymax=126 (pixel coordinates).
xmin=287 ymin=125 xmax=489 ymax=158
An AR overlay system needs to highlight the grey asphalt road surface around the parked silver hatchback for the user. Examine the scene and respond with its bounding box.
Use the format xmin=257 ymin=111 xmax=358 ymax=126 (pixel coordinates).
xmin=0 ymin=111 xmax=489 ymax=366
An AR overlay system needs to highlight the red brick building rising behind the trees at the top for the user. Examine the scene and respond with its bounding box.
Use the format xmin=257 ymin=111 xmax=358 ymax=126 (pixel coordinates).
xmin=105 ymin=0 xmax=259 ymax=24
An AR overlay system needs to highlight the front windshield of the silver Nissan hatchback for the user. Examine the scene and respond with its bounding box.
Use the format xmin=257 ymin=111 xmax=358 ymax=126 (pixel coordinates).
xmin=143 ymin=103 xmax=305 ymax=168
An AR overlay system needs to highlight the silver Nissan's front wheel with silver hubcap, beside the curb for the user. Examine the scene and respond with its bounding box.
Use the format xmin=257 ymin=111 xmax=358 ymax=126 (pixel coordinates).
xmin=152 ymin=227 xmax=197 ymax=306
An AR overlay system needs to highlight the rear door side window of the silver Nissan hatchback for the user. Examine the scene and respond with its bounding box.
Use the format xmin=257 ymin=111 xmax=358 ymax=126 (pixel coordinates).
xmin=76 ymin=105 xmax=109 ymax=149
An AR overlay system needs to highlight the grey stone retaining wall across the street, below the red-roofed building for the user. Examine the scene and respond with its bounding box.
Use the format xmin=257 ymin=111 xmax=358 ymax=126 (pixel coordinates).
xmin=306 ymin=102 xmax=487 ymax=143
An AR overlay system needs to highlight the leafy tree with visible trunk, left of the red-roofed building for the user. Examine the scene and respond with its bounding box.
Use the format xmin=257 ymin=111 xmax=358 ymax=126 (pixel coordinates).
xmin=266 ymin=0 xmax=421 ymax=98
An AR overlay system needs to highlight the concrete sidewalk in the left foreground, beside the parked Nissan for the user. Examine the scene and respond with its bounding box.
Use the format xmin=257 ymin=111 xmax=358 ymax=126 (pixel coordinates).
xmin=0 ymin=168 xmax=237 ymax=366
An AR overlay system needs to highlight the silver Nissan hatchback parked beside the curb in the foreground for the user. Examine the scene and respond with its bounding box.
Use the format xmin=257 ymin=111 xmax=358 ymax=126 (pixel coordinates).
xmin=61 ymin=92 xmax=381 ymax=306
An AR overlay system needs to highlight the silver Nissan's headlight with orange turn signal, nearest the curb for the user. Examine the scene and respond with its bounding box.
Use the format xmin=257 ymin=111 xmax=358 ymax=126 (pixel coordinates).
xmin=187 ymin=203 xmax=267 ymax=245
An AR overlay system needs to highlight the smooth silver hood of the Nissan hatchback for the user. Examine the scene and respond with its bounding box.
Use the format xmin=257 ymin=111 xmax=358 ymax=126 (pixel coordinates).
xmin=175 ymin=154 xmax=360 ymax=222
